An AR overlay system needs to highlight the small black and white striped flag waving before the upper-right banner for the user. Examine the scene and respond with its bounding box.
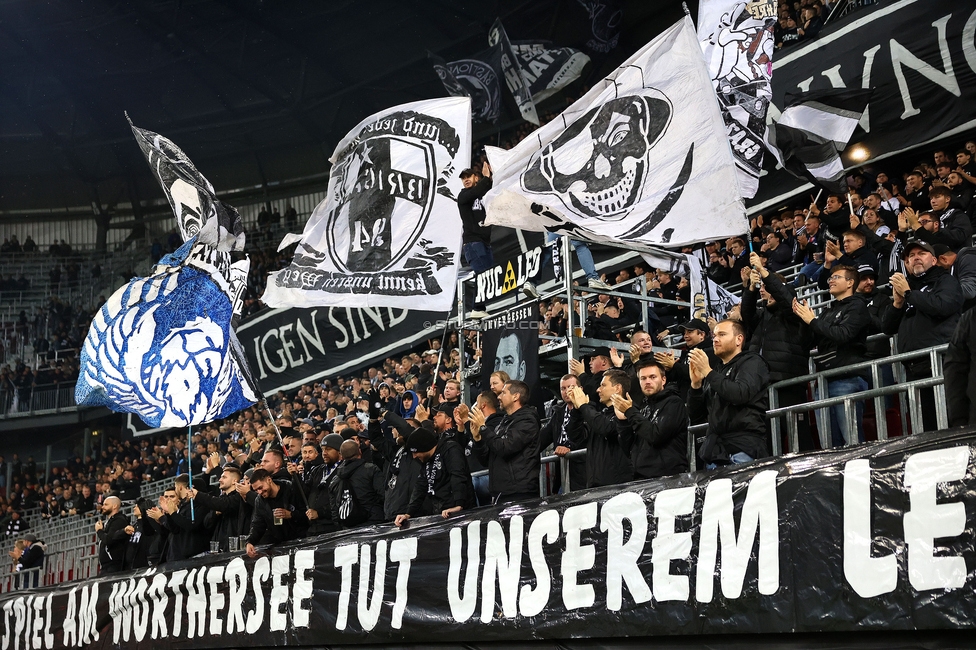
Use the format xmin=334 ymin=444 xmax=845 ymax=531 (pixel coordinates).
xmin=766 ymin=90 xmax=871 ymax=193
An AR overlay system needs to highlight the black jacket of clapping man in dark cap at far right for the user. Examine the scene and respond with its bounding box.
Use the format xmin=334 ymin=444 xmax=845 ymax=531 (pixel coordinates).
xmin=883 ymin=266 xmax=963 ymax=360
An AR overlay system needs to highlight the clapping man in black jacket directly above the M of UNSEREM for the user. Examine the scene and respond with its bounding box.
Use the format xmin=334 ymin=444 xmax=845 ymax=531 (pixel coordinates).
xmin=688 ymin=320 xmax=769 ymax=469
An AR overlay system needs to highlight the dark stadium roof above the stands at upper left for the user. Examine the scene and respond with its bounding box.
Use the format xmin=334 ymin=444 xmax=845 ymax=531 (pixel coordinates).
xmin=0 ymin=0 xmax=696 ymax=215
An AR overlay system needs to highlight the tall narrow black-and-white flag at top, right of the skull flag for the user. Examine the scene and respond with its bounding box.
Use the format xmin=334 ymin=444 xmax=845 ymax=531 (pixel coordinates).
xmin=698 ymin=0 xmax=776 ymax=199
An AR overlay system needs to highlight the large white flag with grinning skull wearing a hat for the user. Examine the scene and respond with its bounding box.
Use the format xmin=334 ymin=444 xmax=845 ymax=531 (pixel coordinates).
xmin=485 ymin=17 xmax=748 ymax=249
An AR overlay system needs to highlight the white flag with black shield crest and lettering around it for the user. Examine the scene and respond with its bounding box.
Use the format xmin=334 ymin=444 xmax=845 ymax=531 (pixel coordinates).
xmin=264 ymin=97 xmax=471 ymax=311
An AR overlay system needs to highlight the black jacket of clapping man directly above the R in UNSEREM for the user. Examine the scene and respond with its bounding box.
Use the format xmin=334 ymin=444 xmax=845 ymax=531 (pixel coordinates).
xmin=571 ymin=403 xmax=634 ymax=488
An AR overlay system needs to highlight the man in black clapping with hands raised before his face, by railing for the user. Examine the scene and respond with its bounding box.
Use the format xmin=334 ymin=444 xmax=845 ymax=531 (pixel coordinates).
xmin=741 ymin=253 xmax=815 ymax=451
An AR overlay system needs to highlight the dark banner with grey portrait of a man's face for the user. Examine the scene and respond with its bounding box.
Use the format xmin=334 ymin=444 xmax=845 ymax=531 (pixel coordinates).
xmin=481 ymin=302 xmax=539 ymax=388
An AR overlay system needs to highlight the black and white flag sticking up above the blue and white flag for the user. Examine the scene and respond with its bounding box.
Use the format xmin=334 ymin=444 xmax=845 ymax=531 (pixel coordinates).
xmin=126 ymin=115 xmax=244 ymax=252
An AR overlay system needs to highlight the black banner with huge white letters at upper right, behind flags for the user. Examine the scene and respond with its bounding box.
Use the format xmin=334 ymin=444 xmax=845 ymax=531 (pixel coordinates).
xmin=750 ymin=0 xmax=976 ymax=211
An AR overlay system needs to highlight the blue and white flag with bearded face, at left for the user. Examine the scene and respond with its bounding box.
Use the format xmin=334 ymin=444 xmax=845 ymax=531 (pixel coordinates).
xmin=75 ymin=237 xmax=257 ymax=428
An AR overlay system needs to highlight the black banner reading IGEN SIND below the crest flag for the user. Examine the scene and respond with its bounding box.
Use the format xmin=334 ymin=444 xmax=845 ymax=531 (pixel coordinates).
xmin=237 ymin=307 xmax=445 ymax=394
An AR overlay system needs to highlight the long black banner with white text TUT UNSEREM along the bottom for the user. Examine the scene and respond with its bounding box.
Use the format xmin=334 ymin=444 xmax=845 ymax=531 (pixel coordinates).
xmin=0 ymin=430 xmax=976 ymax=650
